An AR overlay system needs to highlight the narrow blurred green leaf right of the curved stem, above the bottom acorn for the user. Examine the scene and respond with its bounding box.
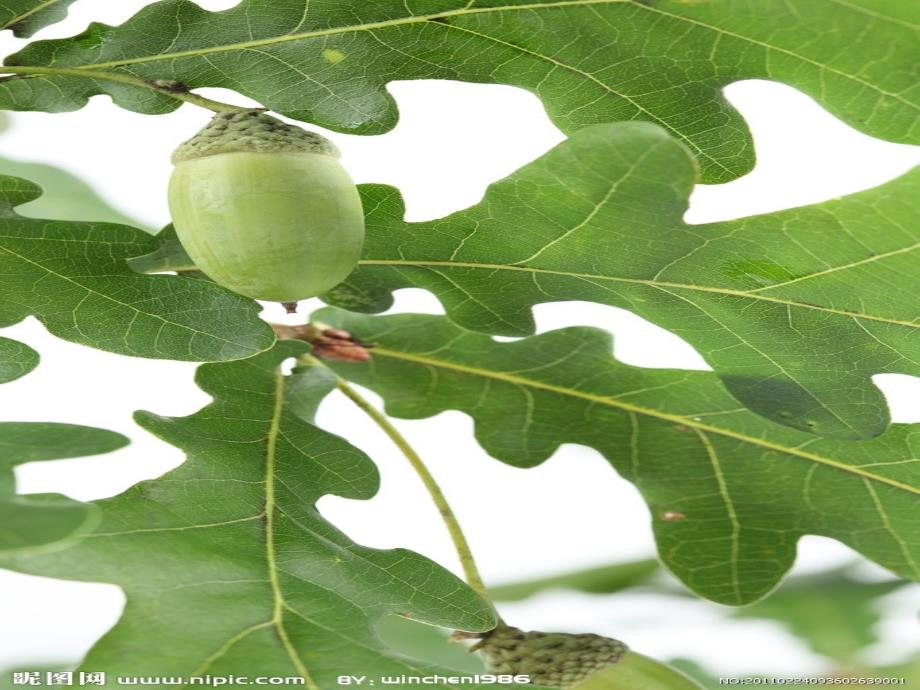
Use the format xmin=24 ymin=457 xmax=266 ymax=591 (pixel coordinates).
xmin=489 ymin=559 xmax=660 ymax=601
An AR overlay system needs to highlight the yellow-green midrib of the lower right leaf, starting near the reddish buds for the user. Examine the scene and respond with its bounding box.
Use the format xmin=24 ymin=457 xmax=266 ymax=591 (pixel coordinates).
xmin=373 ymin=346 xmax=920 ymax=494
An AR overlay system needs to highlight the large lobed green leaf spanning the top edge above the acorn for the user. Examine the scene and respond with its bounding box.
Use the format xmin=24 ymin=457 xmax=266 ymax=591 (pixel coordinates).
xmin=0 ymin=0 xmax=920 ymax=182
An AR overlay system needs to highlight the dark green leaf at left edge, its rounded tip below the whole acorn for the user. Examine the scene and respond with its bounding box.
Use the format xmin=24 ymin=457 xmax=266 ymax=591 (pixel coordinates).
xmin=0 ymin=177 xmax=274 ymax=361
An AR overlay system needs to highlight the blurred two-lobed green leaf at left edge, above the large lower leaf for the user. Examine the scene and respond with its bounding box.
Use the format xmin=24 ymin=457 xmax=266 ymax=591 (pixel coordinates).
xmin=0 ymin=422 xmax=128 ymax=555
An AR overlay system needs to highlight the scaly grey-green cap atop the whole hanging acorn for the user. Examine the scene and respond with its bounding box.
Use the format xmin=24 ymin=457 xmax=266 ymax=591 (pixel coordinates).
xmin=172 ymin=110 xmax=339 ymax=165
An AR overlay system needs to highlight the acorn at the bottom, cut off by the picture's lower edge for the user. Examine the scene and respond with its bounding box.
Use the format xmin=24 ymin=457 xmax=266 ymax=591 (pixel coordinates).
xmin=471 ymin=626 xmax=702 ymax=690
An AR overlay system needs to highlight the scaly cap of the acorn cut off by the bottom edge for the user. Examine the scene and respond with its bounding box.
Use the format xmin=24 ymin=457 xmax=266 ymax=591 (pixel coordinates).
xmin=473 ymin=626 xmax=629 ymax=688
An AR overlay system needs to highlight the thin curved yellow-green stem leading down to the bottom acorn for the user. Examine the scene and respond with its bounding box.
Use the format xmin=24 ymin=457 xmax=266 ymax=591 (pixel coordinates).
xmin=328 ymin=368 xmax=494 ymax=607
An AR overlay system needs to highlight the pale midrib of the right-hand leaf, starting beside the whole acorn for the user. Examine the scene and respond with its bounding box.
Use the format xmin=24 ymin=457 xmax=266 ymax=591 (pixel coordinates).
xmin=358 ymin=259 xmax=920 ymax=328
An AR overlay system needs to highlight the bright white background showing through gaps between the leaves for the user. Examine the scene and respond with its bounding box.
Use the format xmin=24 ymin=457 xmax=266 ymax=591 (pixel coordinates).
xmin=0 ymin=0 xmax=920 ymax=674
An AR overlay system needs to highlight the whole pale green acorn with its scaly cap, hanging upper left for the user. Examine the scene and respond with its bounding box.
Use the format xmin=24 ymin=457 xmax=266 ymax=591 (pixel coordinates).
xmin=169 ymin=110 xmax=364 ymax=304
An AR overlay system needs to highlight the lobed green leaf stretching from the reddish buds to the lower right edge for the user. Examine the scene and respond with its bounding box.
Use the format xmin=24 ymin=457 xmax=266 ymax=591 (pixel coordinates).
xmin=314 ymin=308 xmax=920 ymax=605
